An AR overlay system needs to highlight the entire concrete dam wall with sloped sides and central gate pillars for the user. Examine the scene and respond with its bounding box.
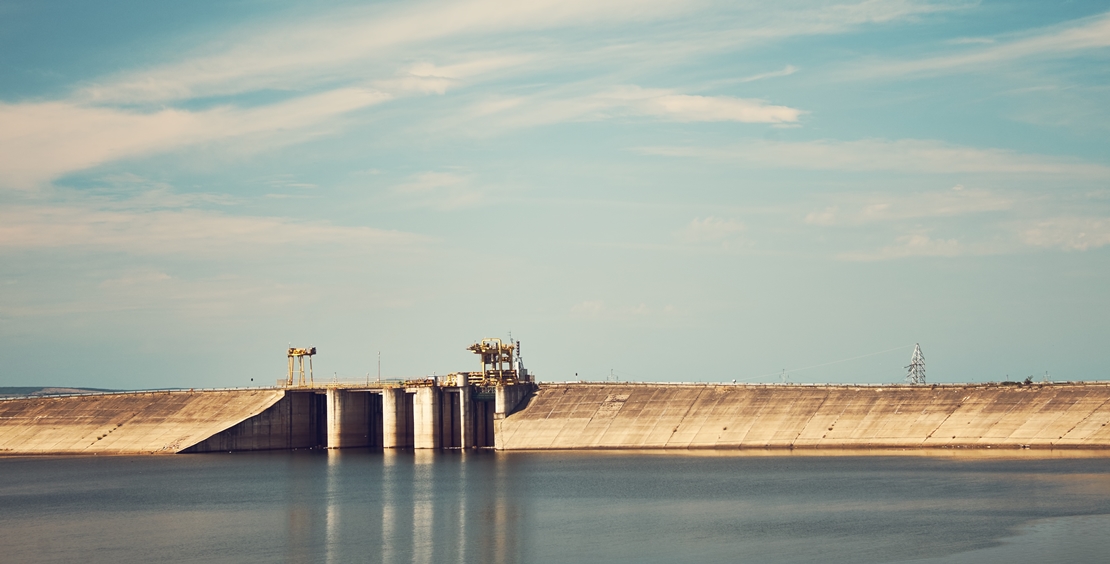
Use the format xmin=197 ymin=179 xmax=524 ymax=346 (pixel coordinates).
xmin=0 ymin=376 xmax=1110 ymax=455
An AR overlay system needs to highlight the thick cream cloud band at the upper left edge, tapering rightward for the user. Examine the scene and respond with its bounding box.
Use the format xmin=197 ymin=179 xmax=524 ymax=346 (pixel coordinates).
xmin=0 ymin=89 xmax=390 ymax=189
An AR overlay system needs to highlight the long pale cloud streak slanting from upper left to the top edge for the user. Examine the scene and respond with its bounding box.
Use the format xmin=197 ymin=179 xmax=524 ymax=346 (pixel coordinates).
xmin=82 ymin=0 xmax=698 ymax=103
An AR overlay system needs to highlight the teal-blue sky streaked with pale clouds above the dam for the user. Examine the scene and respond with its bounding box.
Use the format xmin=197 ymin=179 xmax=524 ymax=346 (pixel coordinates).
xmin=0 ymin=0 xmax=1110 ymax=389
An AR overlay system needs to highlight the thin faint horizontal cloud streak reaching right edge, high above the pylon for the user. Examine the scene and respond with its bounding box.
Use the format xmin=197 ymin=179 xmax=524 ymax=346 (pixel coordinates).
xmin=642 ymin=139 xmax=1110 ymax=178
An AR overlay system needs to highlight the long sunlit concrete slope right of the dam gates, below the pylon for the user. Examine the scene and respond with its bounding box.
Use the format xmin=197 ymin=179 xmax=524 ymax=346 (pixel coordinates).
xmin=497 ymin=383 xmax=1110 ymax=450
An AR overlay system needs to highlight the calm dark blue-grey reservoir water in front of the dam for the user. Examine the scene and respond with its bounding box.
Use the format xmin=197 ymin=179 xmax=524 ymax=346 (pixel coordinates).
xmin=0 ymin=451 xmax=1110 ymax=564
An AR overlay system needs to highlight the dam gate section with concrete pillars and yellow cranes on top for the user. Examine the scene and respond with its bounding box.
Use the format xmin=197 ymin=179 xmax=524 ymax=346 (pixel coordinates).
xmin=181 ymin=339 xmax=534 ymax=452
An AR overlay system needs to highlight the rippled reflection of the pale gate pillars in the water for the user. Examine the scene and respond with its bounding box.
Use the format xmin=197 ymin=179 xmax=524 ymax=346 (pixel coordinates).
xmin=304 ymin=451 xmax=523 ymax=564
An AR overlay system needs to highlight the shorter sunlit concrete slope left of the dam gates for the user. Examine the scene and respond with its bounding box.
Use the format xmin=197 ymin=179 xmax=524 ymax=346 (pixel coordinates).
xmin=0 ymin=390 xmax=284 ymax=454
